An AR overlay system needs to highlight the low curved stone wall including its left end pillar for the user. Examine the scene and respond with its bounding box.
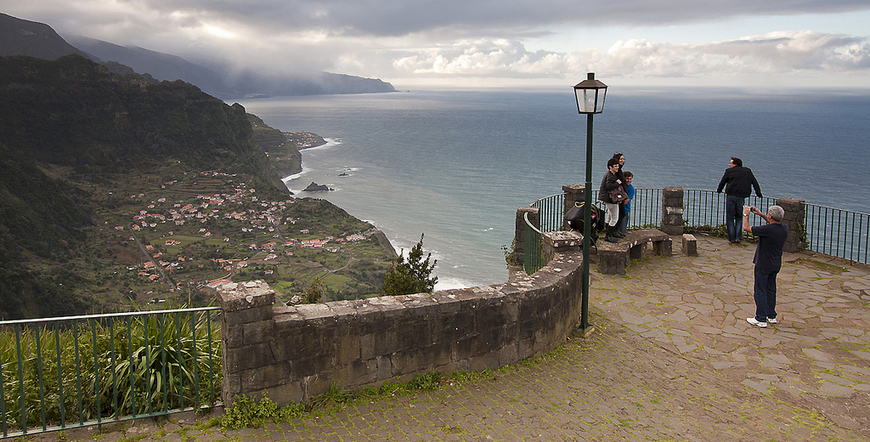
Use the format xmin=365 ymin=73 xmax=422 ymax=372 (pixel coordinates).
xmin=218 ymin=232 xmax=582 ymax=406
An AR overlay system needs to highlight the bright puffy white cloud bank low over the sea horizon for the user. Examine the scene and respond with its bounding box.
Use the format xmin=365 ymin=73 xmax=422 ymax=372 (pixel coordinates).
xmin=393 ymin=31 xmax=870 ymax=78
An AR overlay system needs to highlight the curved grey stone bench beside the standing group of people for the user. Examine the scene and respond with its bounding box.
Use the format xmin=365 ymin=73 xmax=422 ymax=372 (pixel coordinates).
xmin=596 ymin=229 xmax=673 ymax=275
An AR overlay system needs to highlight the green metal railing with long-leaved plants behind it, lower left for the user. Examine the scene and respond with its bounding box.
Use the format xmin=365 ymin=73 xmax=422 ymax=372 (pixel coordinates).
xmin=0 ymin=307 xmax=221 ymax=438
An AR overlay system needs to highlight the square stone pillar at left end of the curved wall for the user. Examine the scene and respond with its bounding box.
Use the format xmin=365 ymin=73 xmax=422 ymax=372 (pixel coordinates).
xmin=218 ymin=281 xmax=276 ymax=407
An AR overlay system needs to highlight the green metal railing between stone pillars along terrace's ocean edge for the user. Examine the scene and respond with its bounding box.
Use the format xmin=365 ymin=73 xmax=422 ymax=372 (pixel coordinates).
xmin=527 ymin=188 xmax=870 ymax=271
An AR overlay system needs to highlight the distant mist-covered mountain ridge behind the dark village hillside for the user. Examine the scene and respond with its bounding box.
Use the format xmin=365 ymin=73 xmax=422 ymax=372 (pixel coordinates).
xmin=0 ymin=13 xmax=396 ymax=99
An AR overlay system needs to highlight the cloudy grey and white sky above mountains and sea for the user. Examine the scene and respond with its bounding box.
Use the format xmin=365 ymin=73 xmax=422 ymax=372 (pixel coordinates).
xmin=0 ymin=0 xmax=870 ymax=90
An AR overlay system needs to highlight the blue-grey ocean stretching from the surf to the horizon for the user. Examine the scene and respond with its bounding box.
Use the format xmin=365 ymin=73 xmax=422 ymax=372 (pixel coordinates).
xmin=240 ymin=85 xmax=870 ymax=289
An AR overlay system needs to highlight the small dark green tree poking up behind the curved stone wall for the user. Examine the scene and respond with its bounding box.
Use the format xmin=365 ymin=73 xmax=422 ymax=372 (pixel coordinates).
xmin=382 ymin=234 xmax=438 ymax=296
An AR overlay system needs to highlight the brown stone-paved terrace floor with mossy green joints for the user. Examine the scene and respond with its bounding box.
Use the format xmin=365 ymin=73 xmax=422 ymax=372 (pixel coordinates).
xmin=25 ymin=236 xmax=870 ymax=442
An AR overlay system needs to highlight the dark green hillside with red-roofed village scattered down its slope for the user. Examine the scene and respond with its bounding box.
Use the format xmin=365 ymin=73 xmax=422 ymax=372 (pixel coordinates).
xmin=0 ymin=55 xmax=393 ymax=319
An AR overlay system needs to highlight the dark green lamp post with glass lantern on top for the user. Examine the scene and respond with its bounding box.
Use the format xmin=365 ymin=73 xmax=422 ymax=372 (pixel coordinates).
xmin=574 ymin=72 xmax=607 ymax=332
